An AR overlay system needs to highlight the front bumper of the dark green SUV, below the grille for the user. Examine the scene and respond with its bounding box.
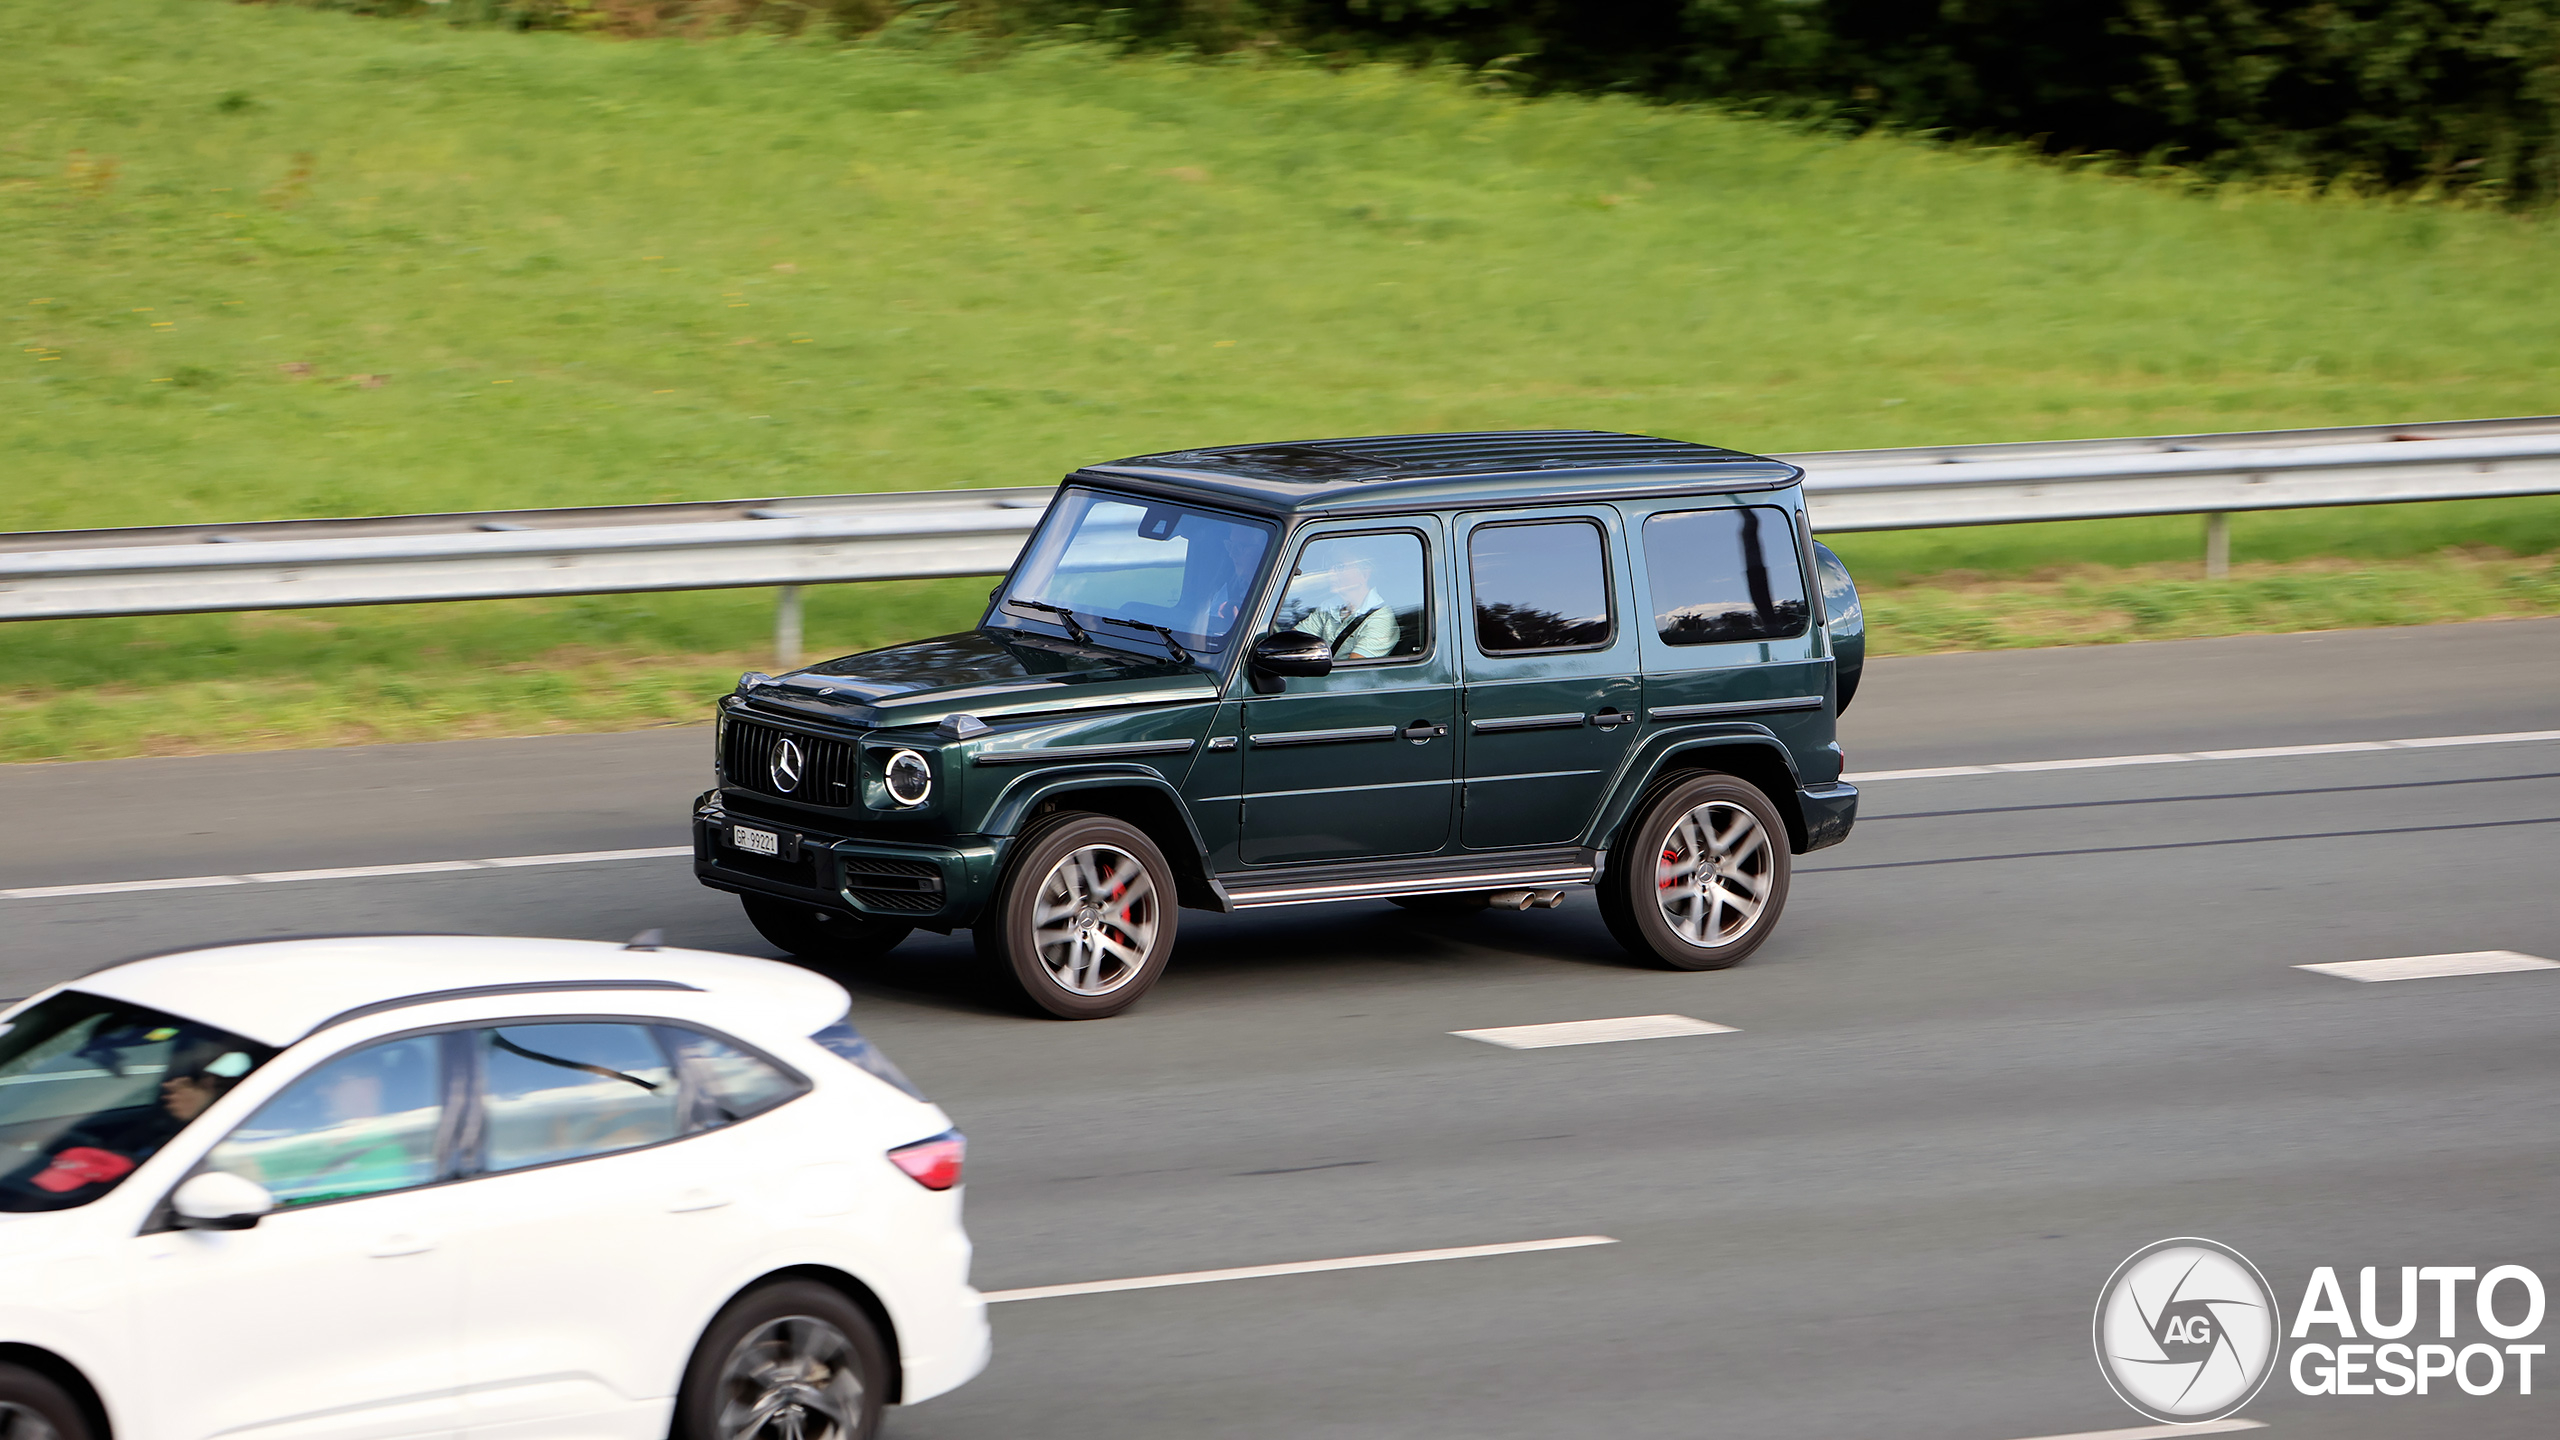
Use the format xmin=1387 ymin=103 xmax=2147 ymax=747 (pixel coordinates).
xmin=694 ymin=789 xmax=996 ymax=930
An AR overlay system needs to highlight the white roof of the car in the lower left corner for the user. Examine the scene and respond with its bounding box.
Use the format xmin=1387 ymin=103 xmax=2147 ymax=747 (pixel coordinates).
xmin=67 ymin=935 xmax=850 ymax=1045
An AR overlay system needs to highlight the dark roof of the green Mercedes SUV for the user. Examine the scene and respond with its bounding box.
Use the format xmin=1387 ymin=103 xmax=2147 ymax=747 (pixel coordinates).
xmin=1068 ymin=430 xmax=1802 ymax=515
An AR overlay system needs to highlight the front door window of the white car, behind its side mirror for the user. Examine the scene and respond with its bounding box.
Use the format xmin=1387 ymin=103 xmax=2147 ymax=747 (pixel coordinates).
xmin=205 ymin=1035 xmax=445 ymax=1207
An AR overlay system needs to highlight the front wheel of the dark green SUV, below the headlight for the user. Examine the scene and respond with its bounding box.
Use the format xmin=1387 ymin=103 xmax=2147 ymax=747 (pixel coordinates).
xmin=978 ymin=812 xmax=1178 ymax=1020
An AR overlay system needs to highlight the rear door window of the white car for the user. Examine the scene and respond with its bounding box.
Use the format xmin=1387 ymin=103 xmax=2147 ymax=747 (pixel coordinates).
xmin=474 ymin=1022 xmax=684 ymax=1171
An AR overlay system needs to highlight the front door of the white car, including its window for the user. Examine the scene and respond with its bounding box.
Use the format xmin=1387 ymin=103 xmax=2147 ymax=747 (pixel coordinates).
xmin=131 ymin=1035 xmax=461 ymax=1440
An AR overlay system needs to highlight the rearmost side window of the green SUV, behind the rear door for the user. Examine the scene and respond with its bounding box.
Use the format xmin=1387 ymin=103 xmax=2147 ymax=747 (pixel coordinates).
xmin=1644 ymin=505 xmax=1807 ymax=646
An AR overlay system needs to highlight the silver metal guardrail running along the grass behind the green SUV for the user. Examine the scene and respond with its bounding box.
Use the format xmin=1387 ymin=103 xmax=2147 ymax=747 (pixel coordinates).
xmin=0 ymin=415 xmax=2560 ymax=656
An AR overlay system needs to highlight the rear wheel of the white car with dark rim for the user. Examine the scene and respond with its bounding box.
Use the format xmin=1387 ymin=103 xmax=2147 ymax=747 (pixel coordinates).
xmin=673 ymin=1281 xmax=888 ymax=1440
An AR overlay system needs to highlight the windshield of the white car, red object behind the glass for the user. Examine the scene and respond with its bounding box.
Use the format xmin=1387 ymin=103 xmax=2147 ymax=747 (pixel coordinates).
xmin=0 ymin=989 xmax=276 ymax=1212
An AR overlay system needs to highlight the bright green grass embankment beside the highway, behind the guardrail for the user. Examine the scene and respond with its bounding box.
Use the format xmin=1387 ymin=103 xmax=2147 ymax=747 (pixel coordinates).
xmin=0 ymin=0 xmax=2560 ymax=758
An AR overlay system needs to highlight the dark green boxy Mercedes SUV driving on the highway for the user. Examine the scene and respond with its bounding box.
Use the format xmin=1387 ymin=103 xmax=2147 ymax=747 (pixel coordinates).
xmin=694 ymin=430 xmax=1864 ymax=1017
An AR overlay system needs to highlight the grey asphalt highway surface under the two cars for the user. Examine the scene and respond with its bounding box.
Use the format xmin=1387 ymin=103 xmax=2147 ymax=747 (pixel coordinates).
xmin=0 ymin=623 xmax=2560 ymax=1440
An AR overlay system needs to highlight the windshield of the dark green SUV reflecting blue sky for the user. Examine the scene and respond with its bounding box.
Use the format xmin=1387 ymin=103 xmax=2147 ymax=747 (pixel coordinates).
xmin=1004 ymin=489 xmax=1272 ymax=653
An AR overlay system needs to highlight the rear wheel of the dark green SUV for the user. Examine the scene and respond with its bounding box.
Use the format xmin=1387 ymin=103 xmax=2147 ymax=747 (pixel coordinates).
xmin=1600 ymin=774 xmax=1795 ymax=971
